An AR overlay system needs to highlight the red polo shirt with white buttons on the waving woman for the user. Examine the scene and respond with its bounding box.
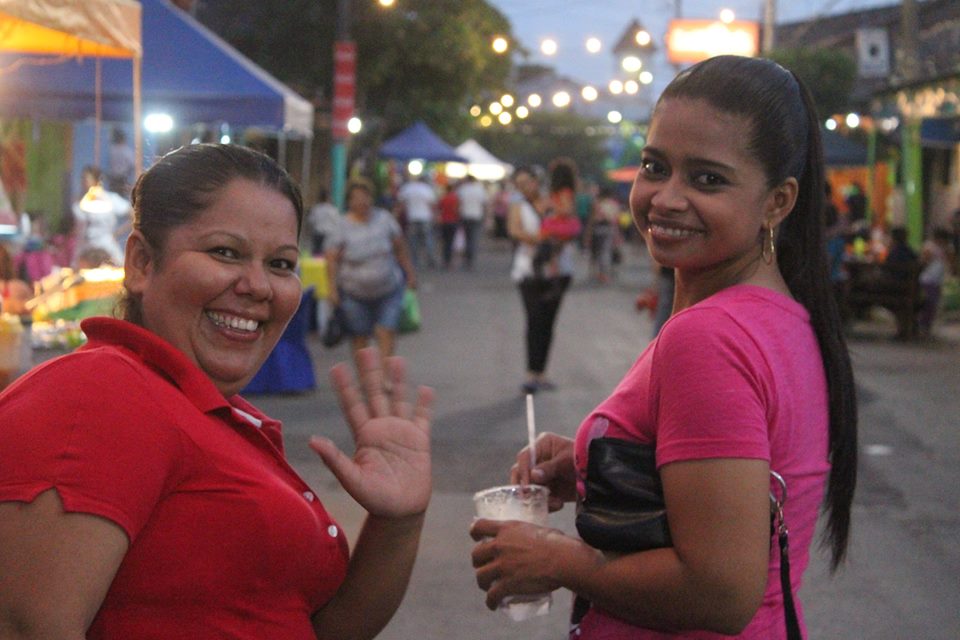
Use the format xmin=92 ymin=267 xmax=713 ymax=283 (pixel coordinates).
xmin=0 ymin=318 xmax=348 ymax=640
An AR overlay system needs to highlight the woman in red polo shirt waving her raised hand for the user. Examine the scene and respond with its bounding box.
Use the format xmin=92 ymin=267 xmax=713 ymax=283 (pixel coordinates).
xmin=0 ymin=145 xmax=432 ymax=640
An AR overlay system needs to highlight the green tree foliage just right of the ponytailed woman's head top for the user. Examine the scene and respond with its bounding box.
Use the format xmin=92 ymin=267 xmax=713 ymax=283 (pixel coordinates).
xmin=770 ymin=49 xmax=857 ymax=118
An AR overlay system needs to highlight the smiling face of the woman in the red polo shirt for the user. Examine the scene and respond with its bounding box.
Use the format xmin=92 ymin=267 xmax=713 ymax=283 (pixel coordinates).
xmin=125 ymin=178 xmax=300 ymax=397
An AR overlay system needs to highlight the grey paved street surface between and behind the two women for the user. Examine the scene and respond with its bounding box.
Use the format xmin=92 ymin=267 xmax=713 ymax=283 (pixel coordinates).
xmin=251 ymin=240 xmax=960 ymax=640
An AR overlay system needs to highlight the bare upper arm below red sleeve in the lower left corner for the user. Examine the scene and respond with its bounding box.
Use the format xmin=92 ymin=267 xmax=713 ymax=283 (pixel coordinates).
xmin=0 ymin=489 xmax=128 ymax=640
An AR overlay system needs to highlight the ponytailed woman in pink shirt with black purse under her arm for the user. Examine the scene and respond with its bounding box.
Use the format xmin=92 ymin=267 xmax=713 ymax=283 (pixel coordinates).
xmin=471 ymin=56 xmax=857 ymax=640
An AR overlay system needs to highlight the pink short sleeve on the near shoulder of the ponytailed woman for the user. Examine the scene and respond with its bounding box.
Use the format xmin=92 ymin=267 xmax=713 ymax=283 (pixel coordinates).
xmin=650 ymin=307 xmax=772 ymax=466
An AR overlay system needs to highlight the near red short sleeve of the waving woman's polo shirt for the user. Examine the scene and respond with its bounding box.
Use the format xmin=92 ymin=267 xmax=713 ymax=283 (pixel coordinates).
xmin=0 ymin=352 xmax=184 ymax=540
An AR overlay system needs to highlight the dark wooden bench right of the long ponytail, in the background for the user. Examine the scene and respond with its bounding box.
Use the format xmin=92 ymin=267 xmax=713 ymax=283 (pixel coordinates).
xmin=840 ymin=262 xmax=923 ymax=339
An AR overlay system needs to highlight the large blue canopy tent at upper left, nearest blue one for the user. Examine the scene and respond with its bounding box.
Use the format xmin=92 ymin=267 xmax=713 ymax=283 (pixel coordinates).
xmin=0 ymin=0 xmax=313 ymax=137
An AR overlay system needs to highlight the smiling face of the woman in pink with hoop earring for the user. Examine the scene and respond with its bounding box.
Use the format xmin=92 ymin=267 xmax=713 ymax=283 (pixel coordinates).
xmin=630 ymin=98 xmax=796 ymax=284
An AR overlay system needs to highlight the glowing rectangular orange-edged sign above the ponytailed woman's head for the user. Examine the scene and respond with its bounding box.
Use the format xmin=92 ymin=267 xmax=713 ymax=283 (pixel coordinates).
xmin=667 ymin=20 xmax=760 ymax=64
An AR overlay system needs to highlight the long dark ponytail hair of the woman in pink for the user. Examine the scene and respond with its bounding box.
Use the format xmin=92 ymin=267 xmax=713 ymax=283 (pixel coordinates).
xmin=657 ymin=56 xmax=857 ymax=571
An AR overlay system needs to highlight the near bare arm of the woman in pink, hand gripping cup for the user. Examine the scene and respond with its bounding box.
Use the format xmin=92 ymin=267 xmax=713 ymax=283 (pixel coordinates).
xmin=472 ymin=459 xmax=770 ymax=634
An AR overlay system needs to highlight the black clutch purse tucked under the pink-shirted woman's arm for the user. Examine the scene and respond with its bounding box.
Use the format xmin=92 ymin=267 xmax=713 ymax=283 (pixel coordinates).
xmin=576 ymin=438 xmax=673 ymax=552
